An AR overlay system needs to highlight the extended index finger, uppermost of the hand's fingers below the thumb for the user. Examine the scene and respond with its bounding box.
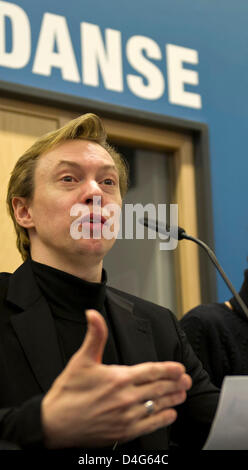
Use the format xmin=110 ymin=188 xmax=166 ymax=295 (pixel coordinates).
xmin=129 ymin=361 xmax=185 ymax=385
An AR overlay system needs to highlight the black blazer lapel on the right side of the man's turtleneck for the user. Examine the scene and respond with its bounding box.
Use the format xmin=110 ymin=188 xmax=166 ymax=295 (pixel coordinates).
xmin=107 ymin=288 xmax=157 ymax=365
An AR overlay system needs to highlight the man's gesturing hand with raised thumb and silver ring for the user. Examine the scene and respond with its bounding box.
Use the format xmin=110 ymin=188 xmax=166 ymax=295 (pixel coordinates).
xmin=42 ymin=310 xmax=191 ymax=448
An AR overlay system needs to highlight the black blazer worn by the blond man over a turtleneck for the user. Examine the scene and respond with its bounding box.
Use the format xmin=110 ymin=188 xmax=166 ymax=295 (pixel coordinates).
xmin=0 ymin=260 xmax=218 ymax=450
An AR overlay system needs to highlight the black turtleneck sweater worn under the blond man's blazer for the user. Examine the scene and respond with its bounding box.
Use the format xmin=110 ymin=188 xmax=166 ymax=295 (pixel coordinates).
xmin=31 ymin=260 xmax=120 ymax=365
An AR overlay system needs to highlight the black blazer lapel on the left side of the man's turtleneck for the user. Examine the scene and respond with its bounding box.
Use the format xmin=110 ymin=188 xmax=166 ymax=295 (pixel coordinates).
xmin=7 ymin=260 xmax=63 ymax=391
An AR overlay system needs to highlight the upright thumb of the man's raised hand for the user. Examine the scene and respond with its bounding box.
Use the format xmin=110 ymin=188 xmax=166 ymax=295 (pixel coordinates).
xmin=81 ymin=310 xmax=108 ymax=363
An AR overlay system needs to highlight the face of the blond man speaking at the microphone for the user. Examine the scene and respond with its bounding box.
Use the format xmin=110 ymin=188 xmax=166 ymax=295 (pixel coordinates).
xmin=25 ymin=140 xmax=122 ymax=261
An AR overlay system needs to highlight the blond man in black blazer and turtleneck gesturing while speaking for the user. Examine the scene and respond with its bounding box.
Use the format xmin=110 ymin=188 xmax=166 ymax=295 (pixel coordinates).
xmin=0 ymin=114 xmax=218 ymax=449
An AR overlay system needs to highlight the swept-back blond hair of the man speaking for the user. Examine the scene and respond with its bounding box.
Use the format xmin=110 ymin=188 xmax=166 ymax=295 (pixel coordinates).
xmin=6 ymin=113 xmax=128 ymax=261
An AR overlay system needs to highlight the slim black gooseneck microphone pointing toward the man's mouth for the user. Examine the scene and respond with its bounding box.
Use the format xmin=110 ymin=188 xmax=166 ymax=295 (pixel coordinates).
xmin=139 ymin=216 xmax=248 ymax=317
